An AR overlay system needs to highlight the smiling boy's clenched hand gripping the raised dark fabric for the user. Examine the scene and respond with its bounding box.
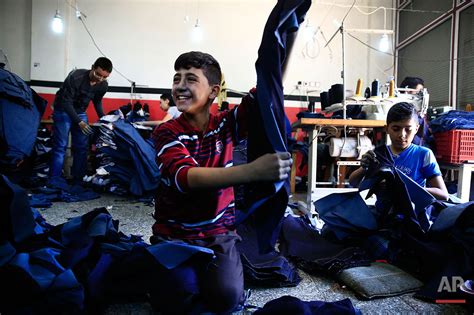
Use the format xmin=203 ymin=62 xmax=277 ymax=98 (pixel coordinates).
xmin=250 ymin=152 xmax=293 ymax=181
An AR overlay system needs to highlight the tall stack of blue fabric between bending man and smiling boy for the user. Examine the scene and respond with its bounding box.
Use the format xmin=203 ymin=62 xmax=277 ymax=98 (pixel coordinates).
xmin=87 ymin=115 xmax=160 ymax=196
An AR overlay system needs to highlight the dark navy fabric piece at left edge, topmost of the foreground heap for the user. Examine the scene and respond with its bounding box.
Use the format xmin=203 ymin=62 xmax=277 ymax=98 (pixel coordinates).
xmin=0 ymin=175 xmax=36 ymax=242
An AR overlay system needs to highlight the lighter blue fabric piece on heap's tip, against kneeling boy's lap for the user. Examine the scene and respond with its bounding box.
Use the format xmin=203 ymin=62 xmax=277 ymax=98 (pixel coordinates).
xmin=147 ymin=241 xmax=214 ymax=269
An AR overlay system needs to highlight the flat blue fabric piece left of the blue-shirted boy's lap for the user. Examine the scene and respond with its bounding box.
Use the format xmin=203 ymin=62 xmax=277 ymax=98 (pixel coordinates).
xmin=314 ymin=191 xmax=377 ymax=240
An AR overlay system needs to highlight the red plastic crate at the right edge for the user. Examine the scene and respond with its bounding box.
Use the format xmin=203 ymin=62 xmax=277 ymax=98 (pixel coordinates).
xmin=434 ymin=129 xmax=474 ymax=164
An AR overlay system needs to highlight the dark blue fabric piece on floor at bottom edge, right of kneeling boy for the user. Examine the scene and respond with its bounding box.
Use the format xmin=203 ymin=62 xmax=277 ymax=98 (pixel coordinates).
xmin=254 ymin=295 xmax=362 ymax=315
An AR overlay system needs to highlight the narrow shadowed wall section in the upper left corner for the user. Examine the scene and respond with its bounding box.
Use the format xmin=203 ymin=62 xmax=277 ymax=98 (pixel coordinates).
xmin=0 ymin=0 xmax=32 ymax=80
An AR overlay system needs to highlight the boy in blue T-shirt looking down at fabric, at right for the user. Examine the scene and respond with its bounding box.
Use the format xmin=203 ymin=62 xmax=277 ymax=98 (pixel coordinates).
xmin=349 ymin=102 xmax=449 ymax=200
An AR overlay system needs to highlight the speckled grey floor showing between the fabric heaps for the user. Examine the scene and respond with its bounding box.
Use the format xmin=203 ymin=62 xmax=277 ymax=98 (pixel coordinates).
xmin=41 ymin=194 xmax=466 ymax=315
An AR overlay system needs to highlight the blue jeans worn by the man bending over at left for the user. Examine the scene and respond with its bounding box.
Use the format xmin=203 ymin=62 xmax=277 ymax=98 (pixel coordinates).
xmin=50 ymin=111 xmax=89 ymax=181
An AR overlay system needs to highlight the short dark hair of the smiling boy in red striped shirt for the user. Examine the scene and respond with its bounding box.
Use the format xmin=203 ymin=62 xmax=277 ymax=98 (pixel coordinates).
xmin=174 ymin=51 xmax=222 ymax=85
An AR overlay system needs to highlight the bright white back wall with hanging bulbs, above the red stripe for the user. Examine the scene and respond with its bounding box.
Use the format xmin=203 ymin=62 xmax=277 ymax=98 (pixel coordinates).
xmin=6 ymin=0 xmax=393 ymax=95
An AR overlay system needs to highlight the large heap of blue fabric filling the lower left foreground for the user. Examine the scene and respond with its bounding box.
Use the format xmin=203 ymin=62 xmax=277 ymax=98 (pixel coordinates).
xmin=0 ymin=175 xmax=213 ymax=314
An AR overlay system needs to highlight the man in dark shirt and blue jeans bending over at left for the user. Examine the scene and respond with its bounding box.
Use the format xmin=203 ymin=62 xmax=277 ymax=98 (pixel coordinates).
xmin=50 ymin=57 xmax=112 ymax=182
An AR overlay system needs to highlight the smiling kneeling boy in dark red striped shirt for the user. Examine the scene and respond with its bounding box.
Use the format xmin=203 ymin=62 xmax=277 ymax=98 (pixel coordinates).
xmin=151 ymin=51 xmax=292 ymax=313
